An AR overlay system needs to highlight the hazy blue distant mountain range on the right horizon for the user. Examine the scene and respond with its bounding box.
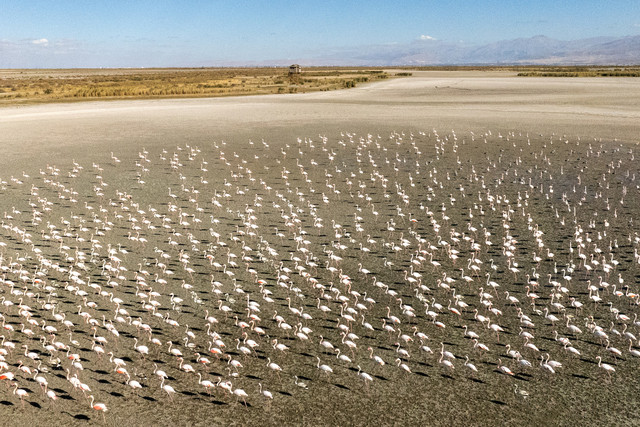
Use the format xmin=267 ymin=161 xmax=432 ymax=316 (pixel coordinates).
xmin=288 ymin=36 xmax=640 ymax=66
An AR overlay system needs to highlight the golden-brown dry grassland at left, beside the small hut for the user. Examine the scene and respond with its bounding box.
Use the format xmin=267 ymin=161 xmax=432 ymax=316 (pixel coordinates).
xmin=0 ymin=68 xmax=389 ymax=105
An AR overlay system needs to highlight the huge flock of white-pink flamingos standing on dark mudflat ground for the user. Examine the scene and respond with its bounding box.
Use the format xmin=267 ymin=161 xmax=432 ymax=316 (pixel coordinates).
xmin=0 ymin=130 xmax=640 ymax=417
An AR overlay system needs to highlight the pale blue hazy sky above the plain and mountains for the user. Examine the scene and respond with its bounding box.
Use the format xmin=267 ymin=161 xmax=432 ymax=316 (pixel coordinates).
xmin=0 ymin=0 xmax=640 ymax=68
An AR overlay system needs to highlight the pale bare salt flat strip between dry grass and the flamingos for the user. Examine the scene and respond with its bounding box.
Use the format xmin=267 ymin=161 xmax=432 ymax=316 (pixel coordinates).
xmin=0 ymin=72 xmax=640 ymax=173
